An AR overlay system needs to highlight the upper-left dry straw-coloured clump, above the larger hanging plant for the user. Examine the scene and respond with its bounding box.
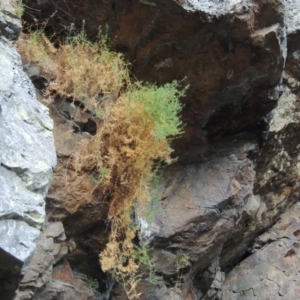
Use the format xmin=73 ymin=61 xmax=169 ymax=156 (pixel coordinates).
xmin=17 ymin=30 xmax=129 ymax=111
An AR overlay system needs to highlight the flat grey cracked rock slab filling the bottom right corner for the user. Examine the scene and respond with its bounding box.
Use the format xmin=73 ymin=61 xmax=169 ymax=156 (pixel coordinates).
xmin=222 ymin=204 xmax=300 ymax=300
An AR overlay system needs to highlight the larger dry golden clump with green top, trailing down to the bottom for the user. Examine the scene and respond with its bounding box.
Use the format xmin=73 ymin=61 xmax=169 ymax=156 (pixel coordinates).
xmin=76 ymin=82 xmax=184 ymax=299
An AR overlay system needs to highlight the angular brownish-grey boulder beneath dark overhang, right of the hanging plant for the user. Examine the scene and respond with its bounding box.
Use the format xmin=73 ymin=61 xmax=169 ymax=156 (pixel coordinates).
xmin=137 ymin=145 xmax=259 ymax=299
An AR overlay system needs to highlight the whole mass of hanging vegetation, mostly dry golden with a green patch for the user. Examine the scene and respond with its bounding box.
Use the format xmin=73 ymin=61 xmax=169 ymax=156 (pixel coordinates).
xmin=18 ymin=27 xmax=186 ymax=299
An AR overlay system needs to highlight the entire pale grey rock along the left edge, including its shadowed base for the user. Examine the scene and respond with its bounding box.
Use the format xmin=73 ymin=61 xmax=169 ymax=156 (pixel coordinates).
xmin=0 ymin=1 xmax=56 ymax=300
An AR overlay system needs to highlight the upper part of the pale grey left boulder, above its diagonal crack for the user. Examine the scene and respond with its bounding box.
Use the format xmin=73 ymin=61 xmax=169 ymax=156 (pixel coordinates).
xmin=0 ymin=42 xmax=56 ymax=196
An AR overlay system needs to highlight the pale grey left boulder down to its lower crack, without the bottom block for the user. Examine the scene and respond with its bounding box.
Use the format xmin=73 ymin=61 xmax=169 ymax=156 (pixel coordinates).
xmin=0 ymin=37 xmax=56 ymax=228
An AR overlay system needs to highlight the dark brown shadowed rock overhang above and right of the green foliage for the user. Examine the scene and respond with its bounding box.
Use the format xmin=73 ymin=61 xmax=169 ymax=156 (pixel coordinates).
xmin=22 ymin=0 xmax=286 ymax=163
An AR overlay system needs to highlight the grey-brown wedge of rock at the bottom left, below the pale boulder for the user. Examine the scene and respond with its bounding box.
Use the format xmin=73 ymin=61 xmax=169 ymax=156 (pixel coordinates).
xmin=14 ymin=222 xmax=95 ymax=300
